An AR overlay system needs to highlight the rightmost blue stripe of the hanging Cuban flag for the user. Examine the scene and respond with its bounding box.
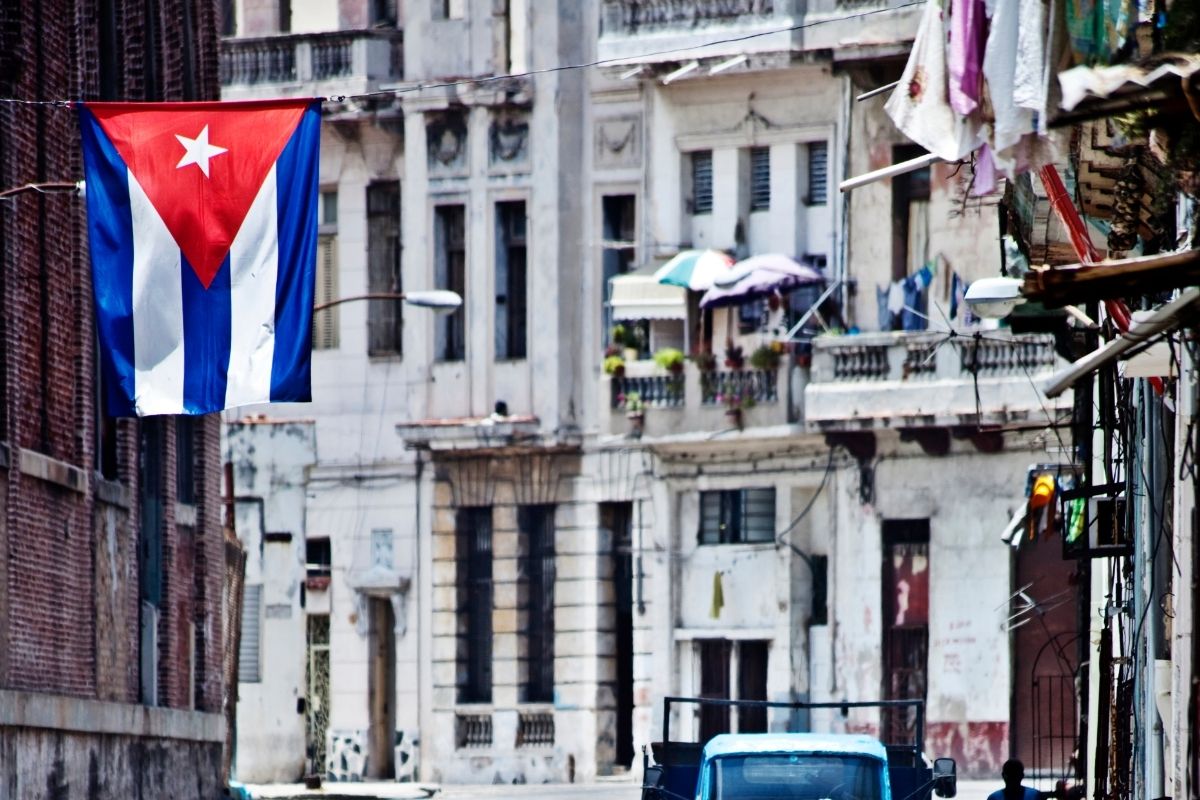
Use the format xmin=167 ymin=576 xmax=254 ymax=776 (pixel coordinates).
xmin=271 ymin=102 xmax=320 ymax=402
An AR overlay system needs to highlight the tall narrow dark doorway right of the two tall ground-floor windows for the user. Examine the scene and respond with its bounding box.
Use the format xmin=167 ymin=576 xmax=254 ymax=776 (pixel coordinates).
xmin=600 ymin=503 xmax=634 ymax=769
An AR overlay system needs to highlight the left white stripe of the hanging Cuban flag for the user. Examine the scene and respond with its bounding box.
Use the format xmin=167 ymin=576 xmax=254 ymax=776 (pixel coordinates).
xmin=128 ymin=172 xmax=184 ymax=416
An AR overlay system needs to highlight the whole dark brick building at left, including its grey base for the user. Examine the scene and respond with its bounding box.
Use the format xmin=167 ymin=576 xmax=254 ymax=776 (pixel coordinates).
xmin=0 ymin=2 xmax=226 ymax=798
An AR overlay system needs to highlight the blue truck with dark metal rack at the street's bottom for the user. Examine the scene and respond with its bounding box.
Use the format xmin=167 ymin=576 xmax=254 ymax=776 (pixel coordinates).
xmin=642 ymin=697 xmax=956 ymax=800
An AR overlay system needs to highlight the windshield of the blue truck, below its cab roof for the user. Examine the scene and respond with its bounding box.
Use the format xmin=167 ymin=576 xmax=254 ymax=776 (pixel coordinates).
xmin=706 ymin=753 xmax=883 ymax=800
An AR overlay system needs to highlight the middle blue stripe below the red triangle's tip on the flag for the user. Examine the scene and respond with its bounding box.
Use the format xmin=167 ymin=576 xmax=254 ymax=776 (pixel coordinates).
xmin=180 ymin=254 xmax=233 ymax=414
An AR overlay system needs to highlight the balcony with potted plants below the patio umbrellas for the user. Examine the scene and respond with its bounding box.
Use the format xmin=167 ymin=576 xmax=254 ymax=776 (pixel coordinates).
xmin=600 ymin=356 xmax=808 ymax=439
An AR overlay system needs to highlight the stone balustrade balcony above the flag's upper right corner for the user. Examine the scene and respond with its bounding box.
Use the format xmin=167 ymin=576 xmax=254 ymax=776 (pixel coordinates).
xmin=221 ymin=30 xmax=404 ymax=100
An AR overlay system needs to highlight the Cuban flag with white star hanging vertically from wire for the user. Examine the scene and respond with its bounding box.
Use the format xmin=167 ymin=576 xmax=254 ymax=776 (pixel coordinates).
xmin=79 ymin=100 xmax=320 ymax=416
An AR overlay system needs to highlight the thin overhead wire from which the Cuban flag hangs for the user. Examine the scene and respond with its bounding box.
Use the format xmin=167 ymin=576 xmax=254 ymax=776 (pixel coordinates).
xmin=0 ymin=0 xmax=925 ymax=108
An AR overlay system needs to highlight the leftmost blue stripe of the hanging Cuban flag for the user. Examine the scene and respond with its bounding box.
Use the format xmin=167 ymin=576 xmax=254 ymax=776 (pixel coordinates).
xmin=79 ymin=104 xmax=134 ymax=416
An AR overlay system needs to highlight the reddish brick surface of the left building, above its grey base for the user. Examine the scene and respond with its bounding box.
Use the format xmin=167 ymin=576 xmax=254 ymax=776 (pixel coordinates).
xmin=0 ymin=0 xmax=223 ymax=711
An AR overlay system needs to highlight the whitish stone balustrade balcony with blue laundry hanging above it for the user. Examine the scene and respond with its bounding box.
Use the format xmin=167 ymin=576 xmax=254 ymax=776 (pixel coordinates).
xmin=804 ymin=331 xmax=1072 ymax=432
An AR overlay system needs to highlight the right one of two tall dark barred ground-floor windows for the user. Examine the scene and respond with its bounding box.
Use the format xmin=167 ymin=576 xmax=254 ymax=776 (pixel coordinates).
xmin=517 ymin=505 xmax=554 ymax=703
